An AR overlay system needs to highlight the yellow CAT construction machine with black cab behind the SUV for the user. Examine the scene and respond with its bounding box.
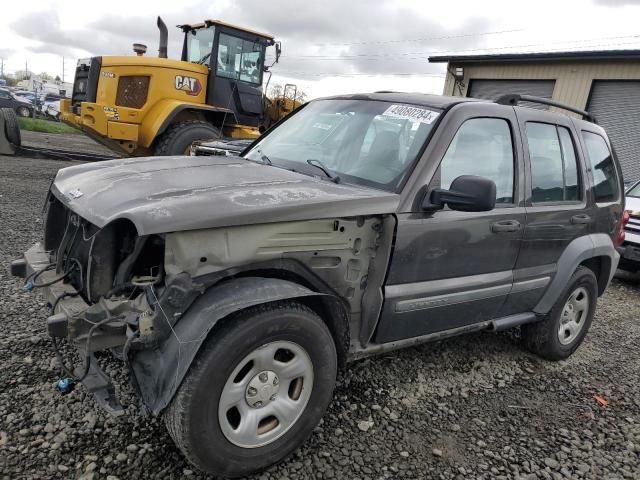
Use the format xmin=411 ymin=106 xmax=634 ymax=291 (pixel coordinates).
xmin=60 ymin=17 xmax=300 ymax=156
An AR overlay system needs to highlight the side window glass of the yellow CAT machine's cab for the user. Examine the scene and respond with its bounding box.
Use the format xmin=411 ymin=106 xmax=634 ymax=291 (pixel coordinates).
xmin=216 ymin=33 xmax=265 ymax=85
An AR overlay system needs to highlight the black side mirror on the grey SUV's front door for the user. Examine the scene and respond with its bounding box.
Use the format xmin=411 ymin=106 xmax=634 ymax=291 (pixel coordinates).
xmin=422 ymin=175 xmax=496 ymax=212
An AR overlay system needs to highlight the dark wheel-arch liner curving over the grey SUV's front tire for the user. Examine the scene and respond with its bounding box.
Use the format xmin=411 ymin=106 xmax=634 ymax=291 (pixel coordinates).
xmin=130 ymin=277 xmax=330 ymax=415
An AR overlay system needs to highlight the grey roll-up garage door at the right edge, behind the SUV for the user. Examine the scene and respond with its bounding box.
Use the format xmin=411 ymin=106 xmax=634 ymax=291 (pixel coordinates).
xmin=587 ymin=80 xmax=640 ymax=183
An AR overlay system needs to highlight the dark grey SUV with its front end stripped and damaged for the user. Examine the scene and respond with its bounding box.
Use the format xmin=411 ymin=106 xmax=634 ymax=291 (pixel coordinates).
xmin=12 ymin=92 xmax=624 ymax=476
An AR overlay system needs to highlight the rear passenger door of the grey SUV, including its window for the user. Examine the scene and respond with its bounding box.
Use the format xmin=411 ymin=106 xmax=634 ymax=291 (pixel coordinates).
xmin=501 ymin=108 xmax=595 ymax=315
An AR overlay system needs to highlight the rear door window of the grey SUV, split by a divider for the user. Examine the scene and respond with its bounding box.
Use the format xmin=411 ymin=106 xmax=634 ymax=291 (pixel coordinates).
xmin=527 ymin=122 xmax=580 ymax=203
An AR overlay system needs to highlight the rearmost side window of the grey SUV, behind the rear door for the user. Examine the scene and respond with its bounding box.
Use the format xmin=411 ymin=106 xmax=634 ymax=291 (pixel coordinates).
xmin=582 ymin=131 xmax=619 ymax=202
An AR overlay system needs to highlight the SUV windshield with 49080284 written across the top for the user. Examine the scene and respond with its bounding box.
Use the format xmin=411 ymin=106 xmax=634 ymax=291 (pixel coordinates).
xmin=245 ymin=100 xmax=439 ymax=191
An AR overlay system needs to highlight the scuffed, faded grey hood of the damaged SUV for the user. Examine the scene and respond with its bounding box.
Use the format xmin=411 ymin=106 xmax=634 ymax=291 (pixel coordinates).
xmin=51 ymin=156 xmax=399 ymax=235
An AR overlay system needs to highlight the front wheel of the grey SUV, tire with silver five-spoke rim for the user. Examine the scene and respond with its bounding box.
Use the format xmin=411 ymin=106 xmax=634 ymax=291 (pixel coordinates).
xmin=164 ymin=301 xmax=337 ymax=477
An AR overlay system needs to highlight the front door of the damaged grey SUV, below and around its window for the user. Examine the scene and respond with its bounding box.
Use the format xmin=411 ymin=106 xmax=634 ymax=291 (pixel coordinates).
xmin=375 ymin=107 xmax=525 ymax=343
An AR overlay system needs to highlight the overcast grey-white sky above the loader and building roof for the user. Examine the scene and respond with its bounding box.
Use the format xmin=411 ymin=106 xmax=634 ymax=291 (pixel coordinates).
xmin=0 ymin=0 xmax=640 ymax=98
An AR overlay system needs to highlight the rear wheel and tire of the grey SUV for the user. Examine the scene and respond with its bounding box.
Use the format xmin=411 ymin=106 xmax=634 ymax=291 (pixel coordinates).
xmin=522 ymin=267 xmax=598 ymax=360
